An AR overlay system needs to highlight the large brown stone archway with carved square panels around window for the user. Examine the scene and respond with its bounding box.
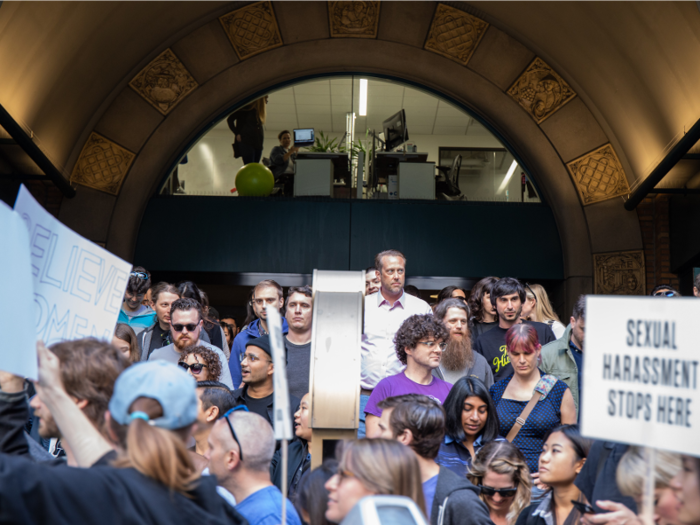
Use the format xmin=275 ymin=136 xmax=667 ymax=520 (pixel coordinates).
xmin=60 ymin=0 xmax=644 ymax=310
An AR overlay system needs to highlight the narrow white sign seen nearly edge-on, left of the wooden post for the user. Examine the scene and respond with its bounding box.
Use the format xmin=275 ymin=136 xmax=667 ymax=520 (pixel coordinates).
xmin=265 ymin=306 xmax=294 ymax=439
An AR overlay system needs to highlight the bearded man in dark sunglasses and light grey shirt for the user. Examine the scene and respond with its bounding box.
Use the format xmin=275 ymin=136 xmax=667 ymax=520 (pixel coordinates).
xmin=148 ymin=298 xmax=233 ymax=390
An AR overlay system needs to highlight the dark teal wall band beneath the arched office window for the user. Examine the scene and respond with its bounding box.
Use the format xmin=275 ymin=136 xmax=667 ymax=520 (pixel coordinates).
xmin=134 ymin=197 xmax=564 ymax=279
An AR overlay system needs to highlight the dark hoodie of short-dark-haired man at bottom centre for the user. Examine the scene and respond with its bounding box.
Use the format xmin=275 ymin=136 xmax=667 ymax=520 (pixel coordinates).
xmin=430 ymin=467 xmax=493 ymax=525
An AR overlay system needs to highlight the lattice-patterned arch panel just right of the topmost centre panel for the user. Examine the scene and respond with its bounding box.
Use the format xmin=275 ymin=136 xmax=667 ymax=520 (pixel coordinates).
xmin=425 ymin=4 xmax=489 ymax=66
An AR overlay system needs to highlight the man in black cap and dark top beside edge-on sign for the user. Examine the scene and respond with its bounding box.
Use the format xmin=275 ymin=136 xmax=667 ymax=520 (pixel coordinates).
xmin=231 ymin=335 xmax=299 ymax=425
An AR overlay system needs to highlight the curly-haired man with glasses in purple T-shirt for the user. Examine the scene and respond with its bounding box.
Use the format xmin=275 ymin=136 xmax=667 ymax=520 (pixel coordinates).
xmin=365 ymin=314 xmax=452 ymax=438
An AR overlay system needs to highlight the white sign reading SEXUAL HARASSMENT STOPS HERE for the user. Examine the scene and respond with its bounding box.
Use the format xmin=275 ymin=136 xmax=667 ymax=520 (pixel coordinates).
xmin=581 ymin=296 xmax=700 ymax=455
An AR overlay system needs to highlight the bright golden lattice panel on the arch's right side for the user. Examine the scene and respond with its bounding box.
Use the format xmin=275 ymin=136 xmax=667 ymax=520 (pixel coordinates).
xmin=566 ymin=144 xmax=630 ymax=206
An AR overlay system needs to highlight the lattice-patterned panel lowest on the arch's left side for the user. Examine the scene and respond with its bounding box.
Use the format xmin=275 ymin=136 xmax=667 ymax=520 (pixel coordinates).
xmin=70 ymin=132 xmax=135 ymax=195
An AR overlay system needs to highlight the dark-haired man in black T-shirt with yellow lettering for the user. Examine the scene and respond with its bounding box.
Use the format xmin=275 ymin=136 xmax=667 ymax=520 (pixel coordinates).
xmin=474 ymin=277 xmax=556 ymax=382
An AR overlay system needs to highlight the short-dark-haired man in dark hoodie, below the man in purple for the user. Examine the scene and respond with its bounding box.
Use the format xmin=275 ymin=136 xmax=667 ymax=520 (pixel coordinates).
xmin=377 ymin=394 xmax=493 ymax=525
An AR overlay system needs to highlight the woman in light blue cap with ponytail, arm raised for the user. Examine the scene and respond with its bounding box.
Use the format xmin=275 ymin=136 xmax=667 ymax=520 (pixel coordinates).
xmin=0 ymin=343 xmax=244 ymax=525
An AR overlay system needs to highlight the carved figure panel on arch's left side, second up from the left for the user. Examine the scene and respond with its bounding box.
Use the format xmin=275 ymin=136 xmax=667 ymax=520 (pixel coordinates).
xmin=129 ymin=49 xmax=197 ymax=115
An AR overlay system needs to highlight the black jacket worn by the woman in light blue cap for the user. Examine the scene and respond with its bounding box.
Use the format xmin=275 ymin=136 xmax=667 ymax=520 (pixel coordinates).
xmin=0 ymin=382 xmax=248 ymax=525
